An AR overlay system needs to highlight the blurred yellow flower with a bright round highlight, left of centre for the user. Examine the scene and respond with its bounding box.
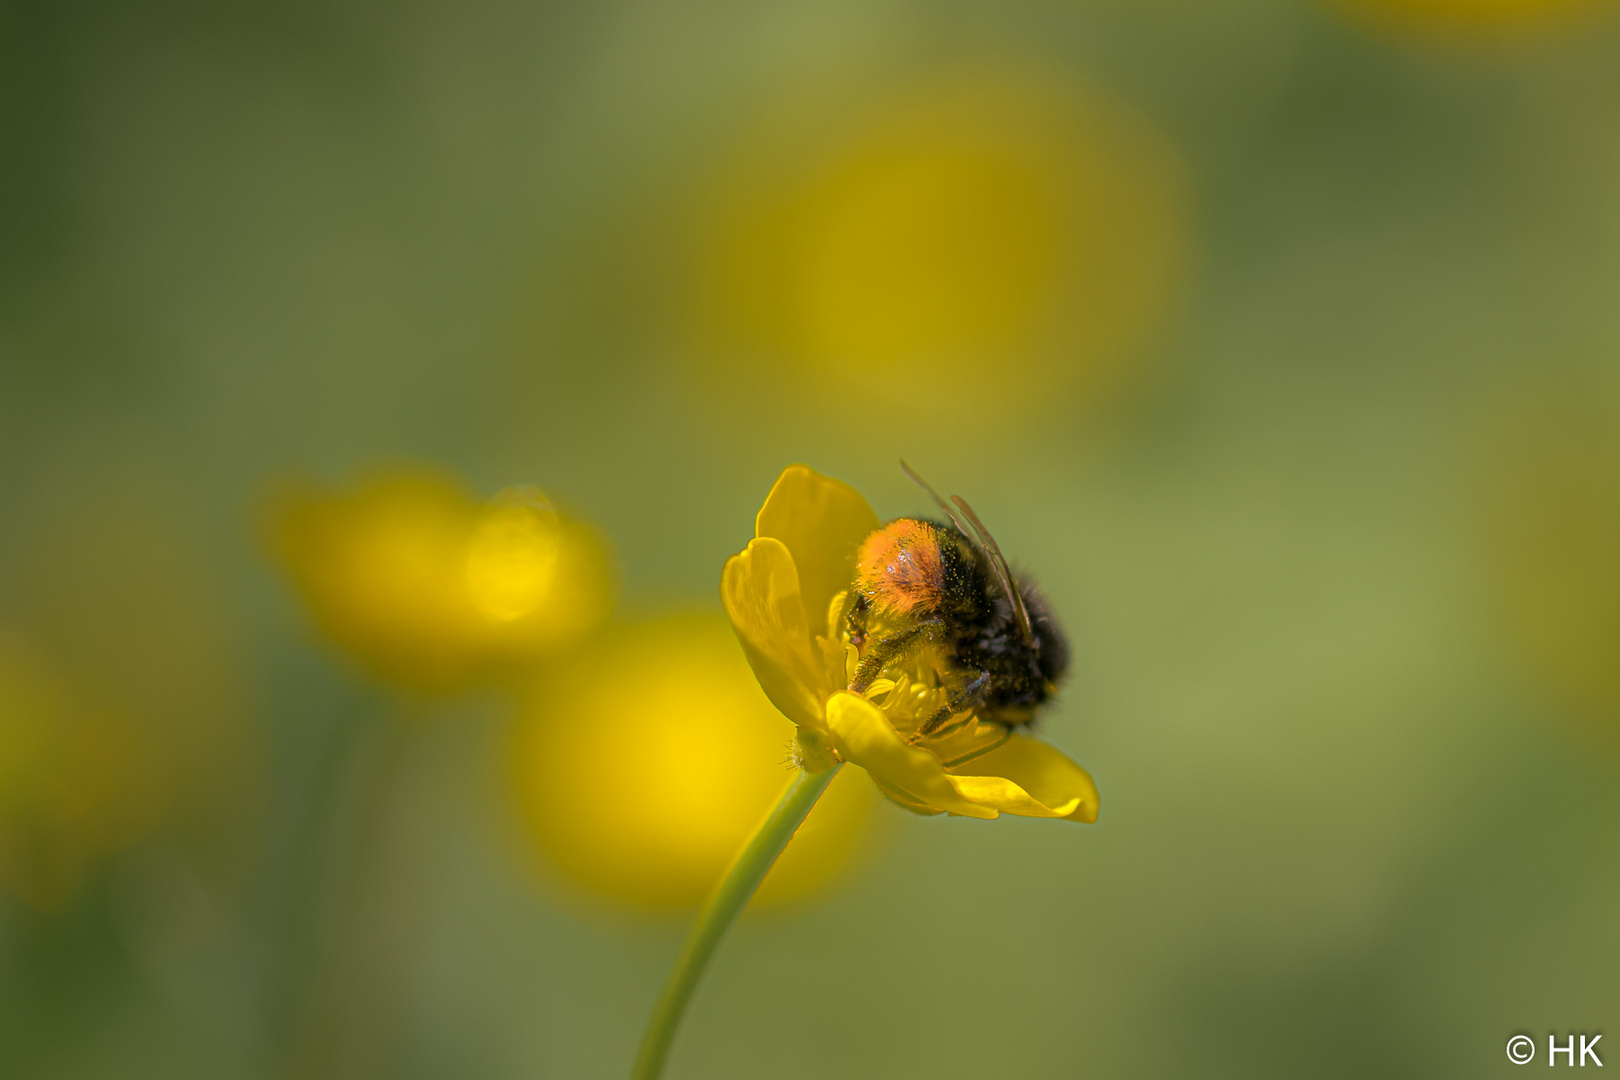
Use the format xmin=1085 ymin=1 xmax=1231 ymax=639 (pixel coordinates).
xmin=272 ymin=471 xmax=612 ymax=691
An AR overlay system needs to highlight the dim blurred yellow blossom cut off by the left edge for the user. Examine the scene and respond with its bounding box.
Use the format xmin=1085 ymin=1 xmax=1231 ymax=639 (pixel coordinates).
xmin=0 ymin=499 xmax=251 ymax=908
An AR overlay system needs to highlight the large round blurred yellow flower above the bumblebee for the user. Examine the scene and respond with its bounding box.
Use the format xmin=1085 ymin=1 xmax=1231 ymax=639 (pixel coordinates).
xmin=692 ymin=68 xmax=1186 ymax=423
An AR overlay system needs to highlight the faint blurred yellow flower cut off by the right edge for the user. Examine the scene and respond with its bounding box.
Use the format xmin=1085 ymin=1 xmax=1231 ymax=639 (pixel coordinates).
xmin=1487 ymin=387 xmax=1620 ymax=730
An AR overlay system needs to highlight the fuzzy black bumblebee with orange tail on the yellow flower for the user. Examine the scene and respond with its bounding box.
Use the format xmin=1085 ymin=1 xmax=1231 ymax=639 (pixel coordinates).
xmin=846 ymin=461 xmax=1069 ymax=738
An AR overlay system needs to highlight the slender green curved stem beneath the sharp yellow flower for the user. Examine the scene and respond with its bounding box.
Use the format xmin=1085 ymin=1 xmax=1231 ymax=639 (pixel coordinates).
xmin=630 ymin=764 xmax=839 ymax=1080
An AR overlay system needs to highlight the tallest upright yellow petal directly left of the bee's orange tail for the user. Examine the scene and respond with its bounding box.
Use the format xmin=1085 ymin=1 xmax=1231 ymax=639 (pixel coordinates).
xmin=753 ymin=465 xmax=881 ymax=631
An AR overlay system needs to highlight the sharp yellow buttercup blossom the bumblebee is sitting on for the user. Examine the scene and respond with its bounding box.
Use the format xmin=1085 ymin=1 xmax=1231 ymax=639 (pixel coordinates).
xmin=721 ymin=465 xmax=1097 ymax=823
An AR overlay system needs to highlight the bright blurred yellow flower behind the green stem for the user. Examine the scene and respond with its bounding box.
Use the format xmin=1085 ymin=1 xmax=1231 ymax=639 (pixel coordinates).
xmin=510 ymin=615 xmax=873 ymax=908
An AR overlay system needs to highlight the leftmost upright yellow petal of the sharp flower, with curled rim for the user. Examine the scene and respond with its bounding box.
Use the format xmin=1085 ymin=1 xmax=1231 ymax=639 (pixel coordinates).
xmin=719 ymin=538 xmax=823 ymax=729
